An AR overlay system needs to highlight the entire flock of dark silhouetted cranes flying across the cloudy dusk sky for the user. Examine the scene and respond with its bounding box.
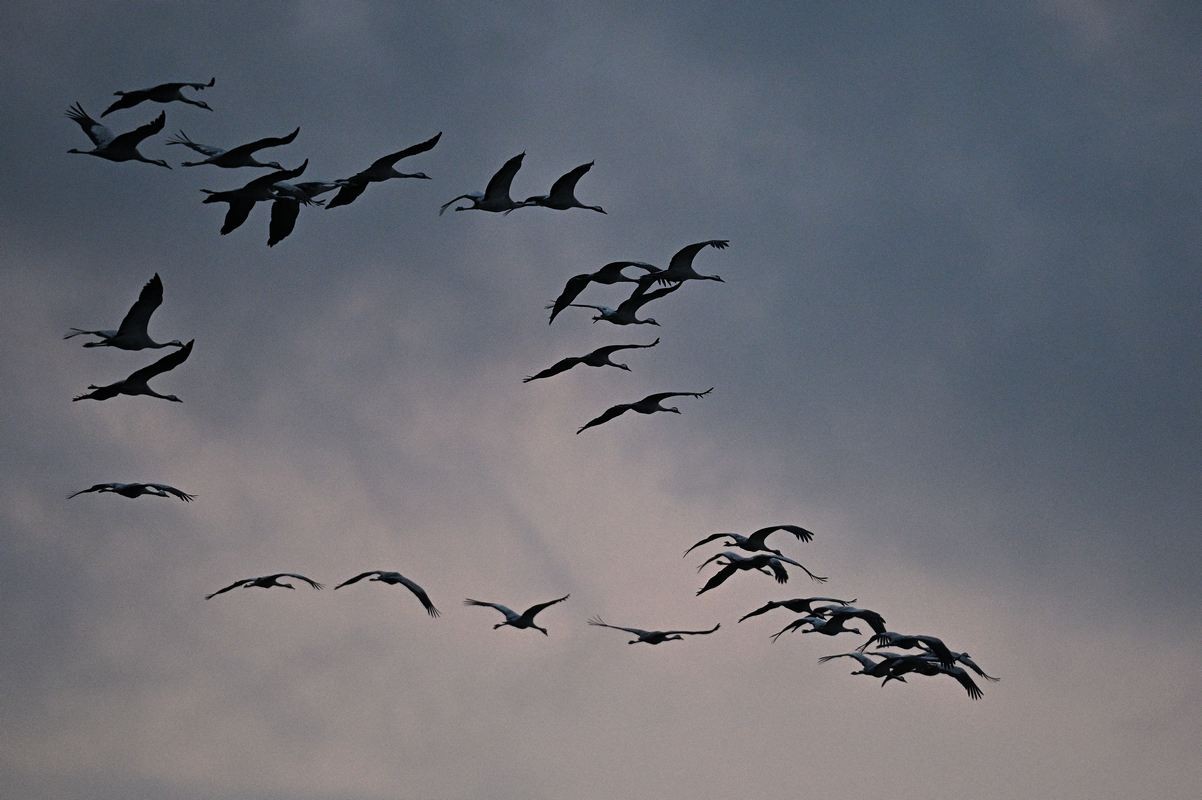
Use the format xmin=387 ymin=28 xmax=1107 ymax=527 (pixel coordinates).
xmin=65 ymin=79 xmax=998 ymax=699
